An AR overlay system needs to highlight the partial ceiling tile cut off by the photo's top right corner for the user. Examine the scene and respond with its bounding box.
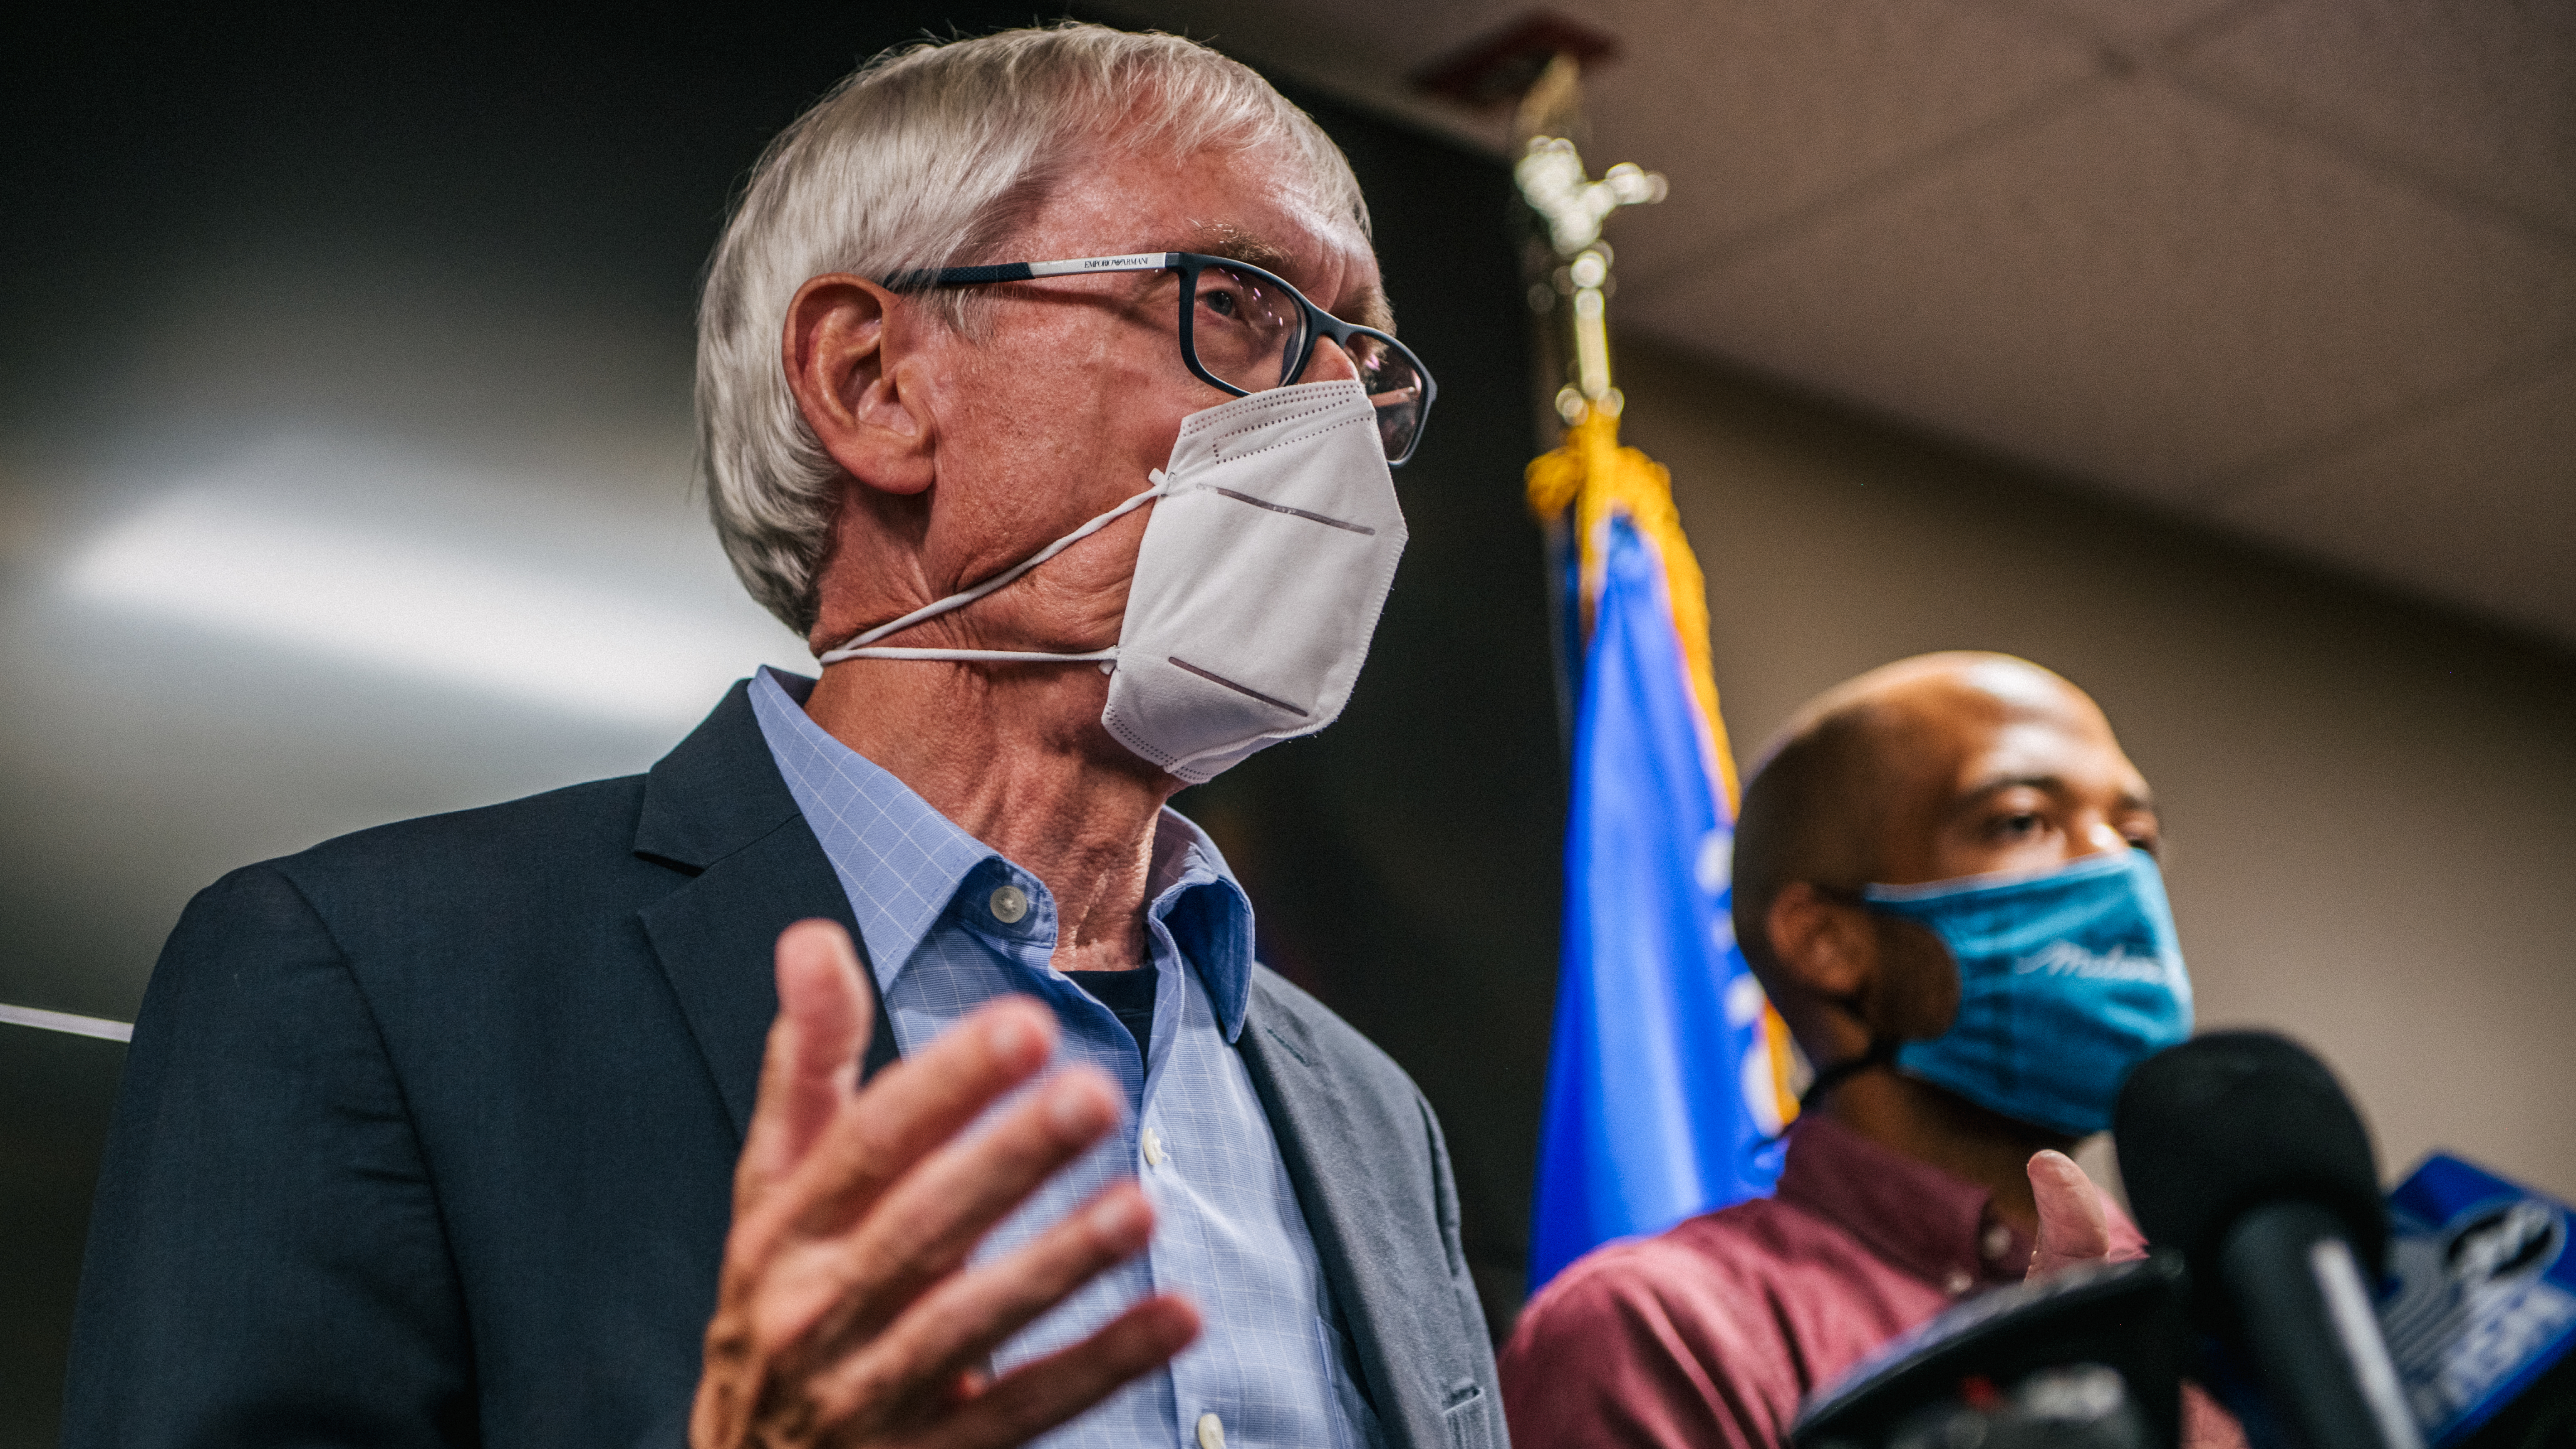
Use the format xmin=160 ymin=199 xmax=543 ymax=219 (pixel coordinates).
xmin=2187 ymin=0 xmax=2576 ymax=235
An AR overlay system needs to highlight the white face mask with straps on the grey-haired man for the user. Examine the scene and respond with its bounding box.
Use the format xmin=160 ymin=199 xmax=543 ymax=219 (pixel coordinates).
xmin=822 ymin=379 xmax=1404 ymax=784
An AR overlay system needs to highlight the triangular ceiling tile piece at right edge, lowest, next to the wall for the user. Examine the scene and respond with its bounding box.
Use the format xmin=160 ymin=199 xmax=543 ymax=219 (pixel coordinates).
xmin=2218 ymin=361 xmax=2576 ymax=639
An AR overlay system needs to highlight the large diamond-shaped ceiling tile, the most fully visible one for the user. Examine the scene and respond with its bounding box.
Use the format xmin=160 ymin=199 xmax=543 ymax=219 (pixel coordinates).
xmin=1618 ymin=77 xmax=2576 ymax=503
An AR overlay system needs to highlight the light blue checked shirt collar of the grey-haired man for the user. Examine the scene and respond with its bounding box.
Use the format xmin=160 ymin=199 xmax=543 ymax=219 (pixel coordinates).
xmin=750 ymin=668 xmax=1252 ymax=1042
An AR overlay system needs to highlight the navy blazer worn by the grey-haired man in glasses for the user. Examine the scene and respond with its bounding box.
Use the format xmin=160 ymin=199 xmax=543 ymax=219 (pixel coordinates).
xmin=64 ymin=683 xmax=1504 ymax=1449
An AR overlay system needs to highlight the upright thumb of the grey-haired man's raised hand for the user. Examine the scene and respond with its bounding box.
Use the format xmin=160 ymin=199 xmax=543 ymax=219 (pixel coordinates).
xmin=734 ymin=921 xmax=873 ymax=1217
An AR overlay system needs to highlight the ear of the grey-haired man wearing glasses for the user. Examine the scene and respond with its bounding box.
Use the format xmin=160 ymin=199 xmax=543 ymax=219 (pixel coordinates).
xmin=780 ymin=273 xmax=938 ymax=493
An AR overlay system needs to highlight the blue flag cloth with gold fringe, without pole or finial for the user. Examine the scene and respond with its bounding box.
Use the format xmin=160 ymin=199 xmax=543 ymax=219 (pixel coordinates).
xmin=1530 ymin=477 xmax=1796 ymax=1292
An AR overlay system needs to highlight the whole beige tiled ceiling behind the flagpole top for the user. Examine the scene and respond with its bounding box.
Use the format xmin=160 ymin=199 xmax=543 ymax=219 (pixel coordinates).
xmin=1108 ymin=0 xmax=2576 ymax=644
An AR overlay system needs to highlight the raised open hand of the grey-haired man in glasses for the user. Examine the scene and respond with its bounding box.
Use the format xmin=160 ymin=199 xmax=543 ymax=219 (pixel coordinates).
xmin=690 ymin=921 xmax=1198 ymax=1449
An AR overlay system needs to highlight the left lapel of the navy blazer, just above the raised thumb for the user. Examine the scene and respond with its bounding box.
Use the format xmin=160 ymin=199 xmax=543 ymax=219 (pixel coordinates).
xmin=634 ymin=681 xmax=894 ymax=1132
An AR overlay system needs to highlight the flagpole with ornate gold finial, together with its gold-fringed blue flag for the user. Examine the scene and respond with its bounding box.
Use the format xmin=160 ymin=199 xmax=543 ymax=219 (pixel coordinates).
xmin=1515 ymin=64 xmax=1798 ymax=1289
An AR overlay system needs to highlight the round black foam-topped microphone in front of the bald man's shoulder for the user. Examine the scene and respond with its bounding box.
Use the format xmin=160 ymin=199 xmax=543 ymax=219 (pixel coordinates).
xmin=2112 ymin=1031 xmax=2424 ymax=1449
